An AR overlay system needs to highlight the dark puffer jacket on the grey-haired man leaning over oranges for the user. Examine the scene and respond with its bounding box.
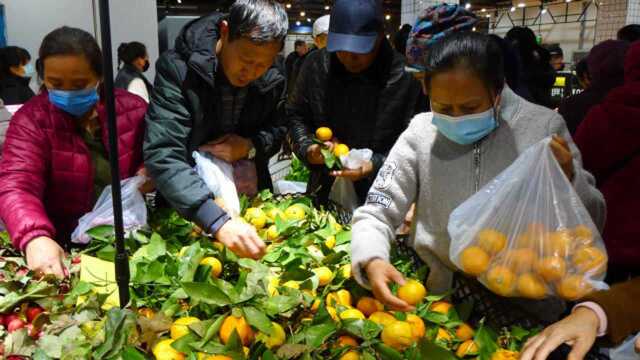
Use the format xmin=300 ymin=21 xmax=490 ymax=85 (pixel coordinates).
xmin=144 ymin=13 xmax=286 ymax=232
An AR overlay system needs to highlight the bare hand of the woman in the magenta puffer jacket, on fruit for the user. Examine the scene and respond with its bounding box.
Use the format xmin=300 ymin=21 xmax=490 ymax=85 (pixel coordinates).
xmin=25 ymin=236 xmax=68 ymax=278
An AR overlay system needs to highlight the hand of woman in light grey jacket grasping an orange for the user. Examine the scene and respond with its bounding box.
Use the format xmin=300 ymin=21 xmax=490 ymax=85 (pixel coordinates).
xmin=365 ymin=259 xmax=415 ymax=311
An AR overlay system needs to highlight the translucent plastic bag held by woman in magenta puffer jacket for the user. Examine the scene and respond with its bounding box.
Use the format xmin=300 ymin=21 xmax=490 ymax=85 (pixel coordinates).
xmin=71 ymin=176 xmax=147 ymax=244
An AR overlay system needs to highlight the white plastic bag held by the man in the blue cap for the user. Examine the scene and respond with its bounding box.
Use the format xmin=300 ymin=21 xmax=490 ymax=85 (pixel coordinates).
xmin=329 ymin=149 xmax=373 ymax=212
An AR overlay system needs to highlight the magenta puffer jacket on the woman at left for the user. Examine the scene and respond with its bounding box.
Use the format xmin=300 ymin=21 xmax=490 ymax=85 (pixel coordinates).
xmin=0 ymin=89 xmax=147 ymax=250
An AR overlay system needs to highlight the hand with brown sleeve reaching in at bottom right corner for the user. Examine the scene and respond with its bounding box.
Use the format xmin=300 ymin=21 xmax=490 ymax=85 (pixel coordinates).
xmin=520 ymin=307 xmax=600 ymax=360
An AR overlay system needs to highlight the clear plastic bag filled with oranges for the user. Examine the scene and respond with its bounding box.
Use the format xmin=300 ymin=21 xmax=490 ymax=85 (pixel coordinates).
xmin=448 ymin=139 xmax=607 ymax=300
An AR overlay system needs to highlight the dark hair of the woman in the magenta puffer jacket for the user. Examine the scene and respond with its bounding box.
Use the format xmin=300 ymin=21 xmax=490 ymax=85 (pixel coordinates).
xmin=37 ymin=26 xmax=103 ymax=78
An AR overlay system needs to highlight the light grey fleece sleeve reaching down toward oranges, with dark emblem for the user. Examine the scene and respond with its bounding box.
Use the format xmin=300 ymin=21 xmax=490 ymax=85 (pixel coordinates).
xmin=351 ymin=119 xmax=420 ymax=287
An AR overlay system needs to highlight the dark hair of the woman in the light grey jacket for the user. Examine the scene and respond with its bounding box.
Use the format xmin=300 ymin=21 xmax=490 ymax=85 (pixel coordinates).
xmin=426 ymin=31 xmax=505 ymax=96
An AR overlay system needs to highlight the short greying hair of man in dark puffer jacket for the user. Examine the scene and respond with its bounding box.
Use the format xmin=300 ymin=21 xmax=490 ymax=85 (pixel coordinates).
xmin=227 ymin=0 xmax=289 ymax=44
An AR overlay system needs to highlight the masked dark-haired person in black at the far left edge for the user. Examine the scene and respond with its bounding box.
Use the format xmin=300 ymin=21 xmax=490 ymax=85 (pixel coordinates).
xmin=0 ymin=46 xmax=35 ymax=105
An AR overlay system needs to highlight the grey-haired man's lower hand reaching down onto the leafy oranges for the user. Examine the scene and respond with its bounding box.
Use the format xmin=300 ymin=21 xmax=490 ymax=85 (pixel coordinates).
xmin=216 ymin=219 xmax=266 ymax=259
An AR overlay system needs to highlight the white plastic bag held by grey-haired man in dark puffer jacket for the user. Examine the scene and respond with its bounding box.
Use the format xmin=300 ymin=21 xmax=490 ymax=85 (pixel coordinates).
xmin=193 ymin=151 xmax=240 ymax=216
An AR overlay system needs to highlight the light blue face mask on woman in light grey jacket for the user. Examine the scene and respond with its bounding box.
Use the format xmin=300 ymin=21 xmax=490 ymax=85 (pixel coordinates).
xmin=433 ymin=108 xmax=498 ymax=145
